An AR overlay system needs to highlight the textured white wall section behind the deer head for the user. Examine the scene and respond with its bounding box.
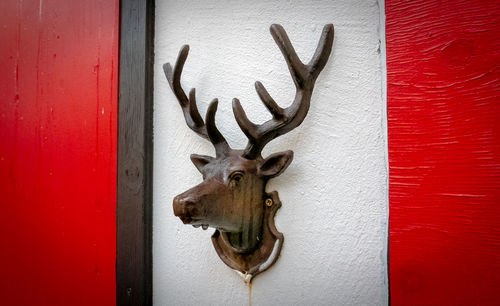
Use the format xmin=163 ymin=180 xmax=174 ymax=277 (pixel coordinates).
xmin=153 ymin=0 xmax=387 ymax=305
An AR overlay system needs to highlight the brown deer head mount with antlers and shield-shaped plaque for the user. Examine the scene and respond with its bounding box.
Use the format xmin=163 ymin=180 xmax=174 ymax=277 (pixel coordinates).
xmin=163 ymin=24 xmax=334 ymax=282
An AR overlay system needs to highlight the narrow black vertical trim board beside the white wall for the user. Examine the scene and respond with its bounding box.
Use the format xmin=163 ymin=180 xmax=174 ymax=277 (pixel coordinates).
xmin=116 ymin=0 xmax=154 ymax=305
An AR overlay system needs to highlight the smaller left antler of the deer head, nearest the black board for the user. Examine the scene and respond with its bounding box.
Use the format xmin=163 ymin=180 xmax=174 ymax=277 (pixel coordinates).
xmin=163 ymin=45 xmax=229 ymax=156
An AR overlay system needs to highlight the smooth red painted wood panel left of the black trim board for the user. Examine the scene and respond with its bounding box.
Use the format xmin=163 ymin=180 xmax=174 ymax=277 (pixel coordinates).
xmin=0 ymin=0 xmax=119 ymax=305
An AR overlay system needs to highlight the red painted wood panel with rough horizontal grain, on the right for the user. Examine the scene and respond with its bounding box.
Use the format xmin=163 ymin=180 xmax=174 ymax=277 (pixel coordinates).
xmin=386 ymin=0 xmax=500 ymax=305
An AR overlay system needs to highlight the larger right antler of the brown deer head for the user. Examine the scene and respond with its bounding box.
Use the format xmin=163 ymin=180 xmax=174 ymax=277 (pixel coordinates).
xmin=233 ymin=24 xmax=334 ymax=159
